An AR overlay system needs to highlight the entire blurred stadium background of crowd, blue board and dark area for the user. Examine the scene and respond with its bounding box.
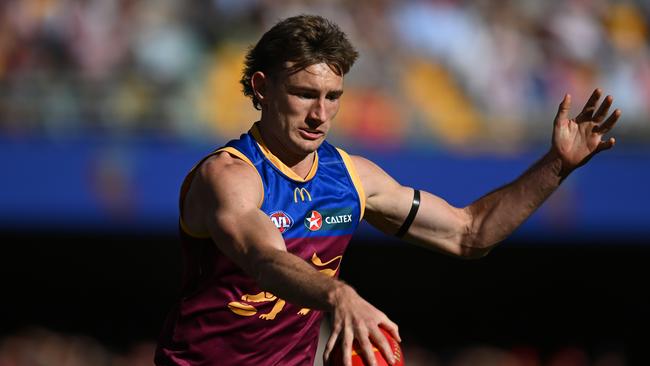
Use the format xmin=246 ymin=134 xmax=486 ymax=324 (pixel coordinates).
xmin=0 ymin=0 xmax=650 ymax=366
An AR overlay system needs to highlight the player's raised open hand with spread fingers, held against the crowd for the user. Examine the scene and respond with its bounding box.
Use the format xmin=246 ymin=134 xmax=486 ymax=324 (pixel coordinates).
xmin=553 ymin=89 xmax=621 ymax=175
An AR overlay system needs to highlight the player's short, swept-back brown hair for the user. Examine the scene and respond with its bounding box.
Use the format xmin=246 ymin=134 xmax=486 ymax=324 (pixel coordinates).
xmin=240 ymin=15 xmax=359 ymax=109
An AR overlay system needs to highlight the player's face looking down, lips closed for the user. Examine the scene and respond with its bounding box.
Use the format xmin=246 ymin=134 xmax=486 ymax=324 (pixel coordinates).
xmin=265 ymin=63 xmax=343 ymax=156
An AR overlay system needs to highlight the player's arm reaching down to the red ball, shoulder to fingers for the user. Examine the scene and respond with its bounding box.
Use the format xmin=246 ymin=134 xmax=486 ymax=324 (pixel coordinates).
xmin=183 ymin=152 xmax=399 ymax=365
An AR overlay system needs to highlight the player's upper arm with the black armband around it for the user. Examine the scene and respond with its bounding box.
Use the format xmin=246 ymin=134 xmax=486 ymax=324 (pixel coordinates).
xmin=353 ymin=156 xmax=470 ymax=255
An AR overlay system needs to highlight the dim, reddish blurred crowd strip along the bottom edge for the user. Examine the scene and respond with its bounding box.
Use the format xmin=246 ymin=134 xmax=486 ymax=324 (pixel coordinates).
xmin=0 ymin=328 xmax=628 ymax=366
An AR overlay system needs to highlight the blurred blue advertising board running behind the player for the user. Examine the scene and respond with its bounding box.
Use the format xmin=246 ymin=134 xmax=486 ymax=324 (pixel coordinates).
xmin=0 ymin=137 xmax=650 ymax=241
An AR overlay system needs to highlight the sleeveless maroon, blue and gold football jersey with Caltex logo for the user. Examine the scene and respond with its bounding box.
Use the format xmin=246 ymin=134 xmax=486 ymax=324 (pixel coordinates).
xmin=156 ymin=125 xmax=365 ymax=365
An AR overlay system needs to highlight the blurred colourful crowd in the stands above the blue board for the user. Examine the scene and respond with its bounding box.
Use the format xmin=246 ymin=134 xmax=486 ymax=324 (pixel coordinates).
xmin=0 ymin=0 xmax=650 ymax=149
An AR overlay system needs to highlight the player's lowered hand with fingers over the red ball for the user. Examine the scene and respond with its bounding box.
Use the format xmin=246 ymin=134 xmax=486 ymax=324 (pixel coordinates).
xmin=323 ymin=285 xmax=401 ymax=366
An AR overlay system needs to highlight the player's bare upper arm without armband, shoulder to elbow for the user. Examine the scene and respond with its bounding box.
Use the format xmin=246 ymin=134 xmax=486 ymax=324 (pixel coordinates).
xmin=191 ymin=156 xmax=286 ymax=277
